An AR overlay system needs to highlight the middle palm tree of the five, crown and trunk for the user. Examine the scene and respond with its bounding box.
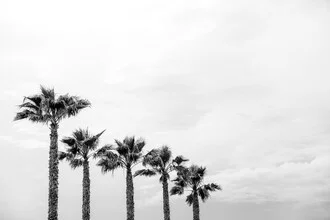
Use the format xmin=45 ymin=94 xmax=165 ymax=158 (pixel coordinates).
xmin=95 ymin=136 xmax=145 ymax=220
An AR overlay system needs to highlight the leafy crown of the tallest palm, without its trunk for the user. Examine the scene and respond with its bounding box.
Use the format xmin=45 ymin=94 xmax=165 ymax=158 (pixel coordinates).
xmin=14 ymin=86 xmax=90 ymax=124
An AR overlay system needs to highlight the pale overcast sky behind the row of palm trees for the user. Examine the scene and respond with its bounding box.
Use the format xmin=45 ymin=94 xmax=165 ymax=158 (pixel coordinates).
xmin=0 ymin=0 xmax=330 ymax=220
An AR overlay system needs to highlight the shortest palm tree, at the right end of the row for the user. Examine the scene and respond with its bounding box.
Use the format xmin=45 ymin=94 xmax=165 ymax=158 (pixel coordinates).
xmin=171 ymin=165 xmax=222 ymax=220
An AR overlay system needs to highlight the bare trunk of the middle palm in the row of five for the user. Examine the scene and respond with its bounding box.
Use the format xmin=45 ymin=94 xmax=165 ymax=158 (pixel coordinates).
xmin=126 ymin=167 xmax=134 ymax=220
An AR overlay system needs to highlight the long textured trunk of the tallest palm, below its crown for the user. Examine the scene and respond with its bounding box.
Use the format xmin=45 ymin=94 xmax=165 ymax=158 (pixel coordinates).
xmin=48 ymin=123 xmax=58 ymax=220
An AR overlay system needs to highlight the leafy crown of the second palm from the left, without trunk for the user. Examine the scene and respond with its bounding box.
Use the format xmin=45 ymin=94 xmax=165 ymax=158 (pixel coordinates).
xmin=59 ymin=129 xmax=105 ymax=166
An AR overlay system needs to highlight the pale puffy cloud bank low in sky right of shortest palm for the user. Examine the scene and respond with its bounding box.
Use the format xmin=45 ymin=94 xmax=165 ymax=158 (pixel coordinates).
xmin=208 ymin=155 xmax=330 ymax=206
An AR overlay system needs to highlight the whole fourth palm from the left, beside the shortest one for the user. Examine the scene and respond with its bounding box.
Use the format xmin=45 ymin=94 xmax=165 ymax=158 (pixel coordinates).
xmin=134 ymin=146 xmax=188 ymax=220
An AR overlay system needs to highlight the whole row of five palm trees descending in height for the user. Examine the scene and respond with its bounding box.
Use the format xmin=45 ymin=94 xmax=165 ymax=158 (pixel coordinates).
xmin=14 ymin=86 xmax=221 ymax=220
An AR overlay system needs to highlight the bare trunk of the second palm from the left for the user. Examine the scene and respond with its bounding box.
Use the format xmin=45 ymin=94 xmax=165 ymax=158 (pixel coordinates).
xmin=82 ymin=160 xmax=91 ymax=220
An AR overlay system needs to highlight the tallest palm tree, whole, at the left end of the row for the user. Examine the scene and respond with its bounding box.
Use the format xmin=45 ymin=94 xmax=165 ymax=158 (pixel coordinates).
xmin=14 ymin=86 xmax=90 ymax=220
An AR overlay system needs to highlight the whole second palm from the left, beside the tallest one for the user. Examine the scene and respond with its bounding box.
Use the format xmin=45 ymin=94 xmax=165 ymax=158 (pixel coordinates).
xmin=58 ymin=129 xmax=104 ymax=220
